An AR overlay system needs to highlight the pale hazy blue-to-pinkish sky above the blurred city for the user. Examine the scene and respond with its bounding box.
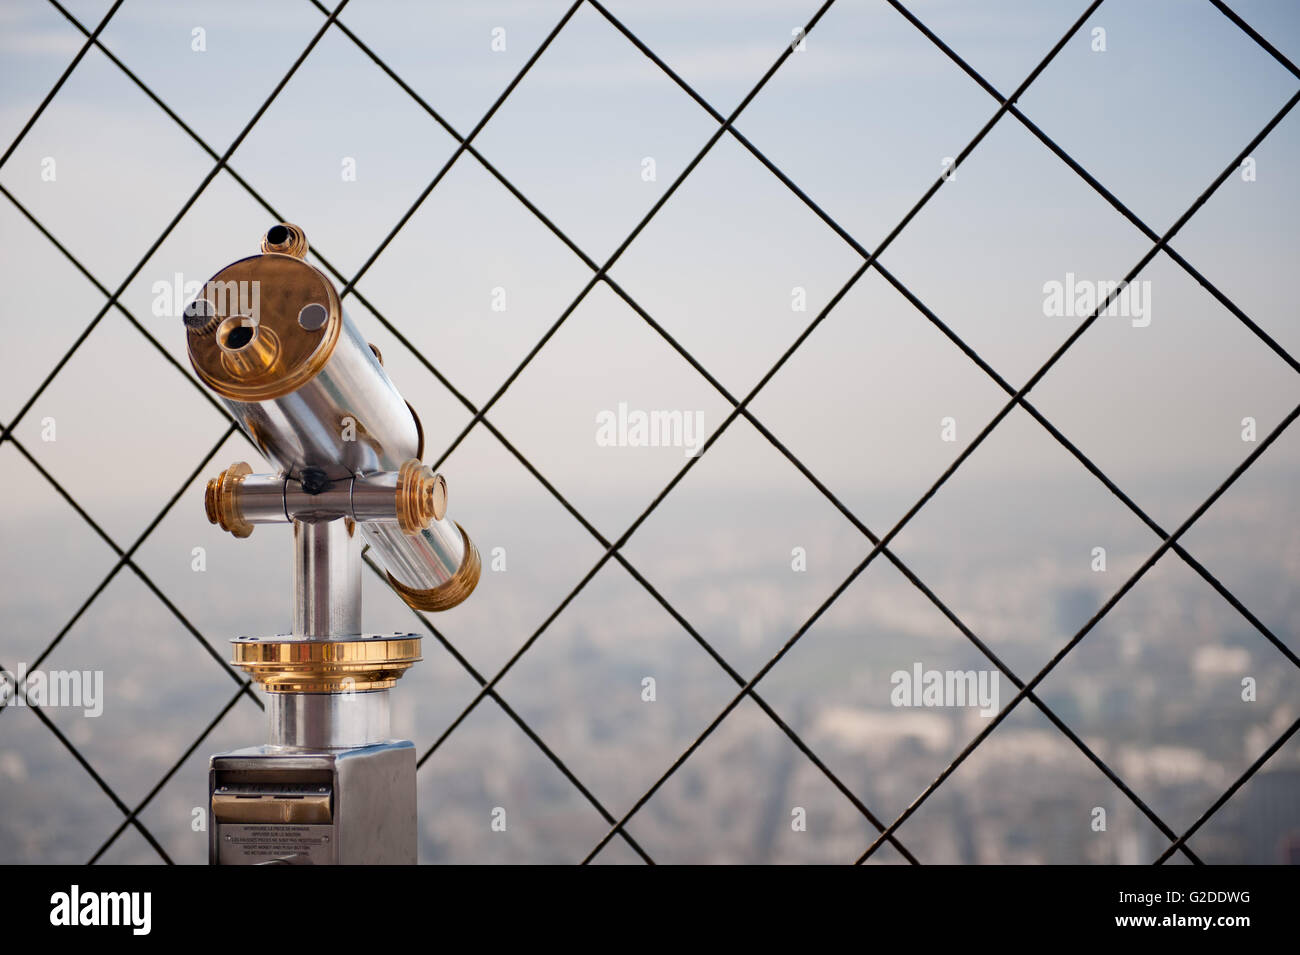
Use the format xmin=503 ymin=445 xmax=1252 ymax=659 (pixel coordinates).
xmin=0 ymin=0 xmax=1300 ymax=545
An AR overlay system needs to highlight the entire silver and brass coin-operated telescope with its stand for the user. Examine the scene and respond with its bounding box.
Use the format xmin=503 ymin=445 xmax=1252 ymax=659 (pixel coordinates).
xmin=185 ymin=222 xmax=480 ymax=865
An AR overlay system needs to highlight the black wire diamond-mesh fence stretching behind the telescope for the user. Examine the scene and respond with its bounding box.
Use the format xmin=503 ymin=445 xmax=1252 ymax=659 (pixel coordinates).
xmin=0 ymin=0 xmax=1300 ymax=863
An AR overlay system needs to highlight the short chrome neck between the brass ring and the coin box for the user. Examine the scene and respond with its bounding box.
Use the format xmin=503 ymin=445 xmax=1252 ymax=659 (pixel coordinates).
xmin=265 ymin=690 xmax=390 ymax=750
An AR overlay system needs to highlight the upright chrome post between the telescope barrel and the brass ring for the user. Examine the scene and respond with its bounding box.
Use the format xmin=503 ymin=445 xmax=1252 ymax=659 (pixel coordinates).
xmin=294 ymin=518 xmax=361 ymax=639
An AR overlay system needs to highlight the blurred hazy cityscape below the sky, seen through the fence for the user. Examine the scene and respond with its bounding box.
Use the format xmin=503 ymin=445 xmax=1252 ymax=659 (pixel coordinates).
xmin=0 ymin=462 xmax=1300 ymax=863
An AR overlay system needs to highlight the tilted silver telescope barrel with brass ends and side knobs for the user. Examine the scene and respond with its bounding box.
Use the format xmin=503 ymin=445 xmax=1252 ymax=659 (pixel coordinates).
xmin=185 ymin=223 xmax=480 ymax=609
